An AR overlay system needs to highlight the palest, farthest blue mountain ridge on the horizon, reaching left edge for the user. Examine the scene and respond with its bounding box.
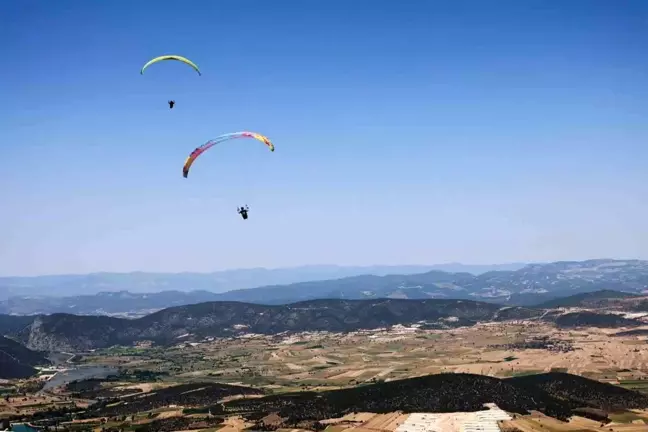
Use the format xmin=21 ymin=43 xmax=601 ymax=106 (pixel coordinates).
xmin=0 ymin=263 xmax=525 ymax=300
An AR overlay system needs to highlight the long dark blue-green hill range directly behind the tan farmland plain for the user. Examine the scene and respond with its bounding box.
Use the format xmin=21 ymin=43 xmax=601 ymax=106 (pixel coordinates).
xmin=0 ymin=299 xmax=643 ymax=352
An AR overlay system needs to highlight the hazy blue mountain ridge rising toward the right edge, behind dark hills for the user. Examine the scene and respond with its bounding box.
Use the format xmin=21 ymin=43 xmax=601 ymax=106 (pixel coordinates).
xmin=214 ymin=259 xmax=648 ymax=305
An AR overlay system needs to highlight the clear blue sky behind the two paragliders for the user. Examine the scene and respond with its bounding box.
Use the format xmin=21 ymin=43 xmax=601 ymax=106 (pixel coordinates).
xmin=0 ymin=0 xmax=648 ymax=275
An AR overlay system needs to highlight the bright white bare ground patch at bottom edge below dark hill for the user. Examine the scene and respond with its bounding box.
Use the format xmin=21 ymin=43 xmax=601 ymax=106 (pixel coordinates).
xmin=395 ymin=404 xmax=511 ymax=432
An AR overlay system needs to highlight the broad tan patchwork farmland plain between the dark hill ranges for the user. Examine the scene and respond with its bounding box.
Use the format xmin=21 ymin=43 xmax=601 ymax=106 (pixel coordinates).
xmin=76 ymin=323 xmax=648 ymax=391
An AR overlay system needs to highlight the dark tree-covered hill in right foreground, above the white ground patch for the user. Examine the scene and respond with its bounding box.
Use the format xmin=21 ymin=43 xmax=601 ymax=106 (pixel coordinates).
xmin=212 ymin=373 xmax=648 ymax=426
